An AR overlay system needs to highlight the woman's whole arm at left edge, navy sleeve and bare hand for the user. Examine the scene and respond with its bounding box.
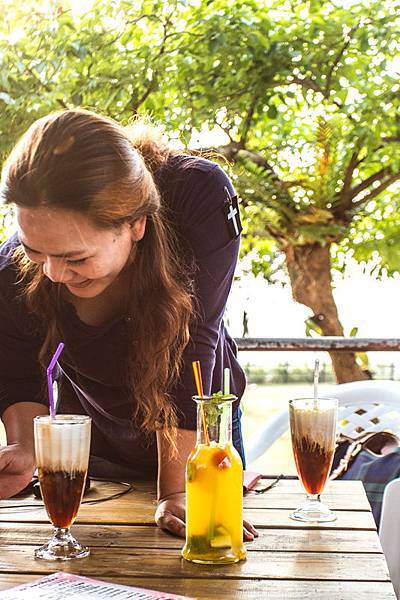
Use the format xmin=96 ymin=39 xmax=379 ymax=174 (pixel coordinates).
xmin=0 ymin=244 xmax=48 ymax=498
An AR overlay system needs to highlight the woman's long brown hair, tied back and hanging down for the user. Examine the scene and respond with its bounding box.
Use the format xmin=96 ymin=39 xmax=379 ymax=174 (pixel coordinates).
xmin=2 ymin=110 xmax=193 ymax=446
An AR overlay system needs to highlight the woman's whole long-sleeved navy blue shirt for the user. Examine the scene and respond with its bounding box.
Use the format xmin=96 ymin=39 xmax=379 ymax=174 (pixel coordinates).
xmin=0 ymin=155 xmax=245 ymax=474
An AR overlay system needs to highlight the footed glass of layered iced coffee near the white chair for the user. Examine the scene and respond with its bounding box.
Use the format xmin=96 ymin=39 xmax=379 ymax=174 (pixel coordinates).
xmin=289 ymin=398 xmax=338 ymax=523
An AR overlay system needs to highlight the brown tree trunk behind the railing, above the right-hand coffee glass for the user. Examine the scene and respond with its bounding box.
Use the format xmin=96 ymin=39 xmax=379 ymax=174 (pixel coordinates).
xmin=285 ymin=243 xmax=369 ymax=383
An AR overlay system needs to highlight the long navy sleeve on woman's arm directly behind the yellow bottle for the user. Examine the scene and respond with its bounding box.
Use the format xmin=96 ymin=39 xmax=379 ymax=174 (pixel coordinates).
xmin=171 ymin=165 xmax=240 ymax=429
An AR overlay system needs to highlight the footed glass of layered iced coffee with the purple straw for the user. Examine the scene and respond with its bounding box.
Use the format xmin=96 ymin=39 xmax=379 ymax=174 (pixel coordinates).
xmin=34 ymin=415 xmax=91 ymax=560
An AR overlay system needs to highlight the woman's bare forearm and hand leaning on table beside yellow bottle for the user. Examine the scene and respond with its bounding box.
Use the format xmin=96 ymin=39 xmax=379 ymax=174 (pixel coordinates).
xmin=155 ymin=429 xmax=196 ymax=537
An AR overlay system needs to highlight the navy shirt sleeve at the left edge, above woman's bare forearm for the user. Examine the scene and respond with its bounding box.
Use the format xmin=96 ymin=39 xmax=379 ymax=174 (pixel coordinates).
xmin=0 ymin=272 xmax=47 ymax=416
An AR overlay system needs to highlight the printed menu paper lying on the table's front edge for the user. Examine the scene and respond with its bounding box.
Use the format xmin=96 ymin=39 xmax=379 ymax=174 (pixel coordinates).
xmin=0 ymin=572 xmax=190 ymax=600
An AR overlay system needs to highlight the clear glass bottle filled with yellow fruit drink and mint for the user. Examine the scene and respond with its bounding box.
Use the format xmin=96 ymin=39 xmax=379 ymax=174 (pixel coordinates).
xmin=182 ymin=395 xmax=246 ymax=564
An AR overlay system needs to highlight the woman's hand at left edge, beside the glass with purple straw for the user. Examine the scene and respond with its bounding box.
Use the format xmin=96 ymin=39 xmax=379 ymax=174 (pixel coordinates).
xmin=0 ymin=443 xmax=35 ymax=499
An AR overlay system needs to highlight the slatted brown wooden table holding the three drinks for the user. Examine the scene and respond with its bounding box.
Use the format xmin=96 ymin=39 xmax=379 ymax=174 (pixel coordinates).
xmin=0 ymin=481 xmax=395 ymax=600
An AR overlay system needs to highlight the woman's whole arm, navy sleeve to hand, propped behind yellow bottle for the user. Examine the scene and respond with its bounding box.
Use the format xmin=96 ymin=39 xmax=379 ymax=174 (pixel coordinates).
xmin=156 ymin=160 xmax=257 ymax=540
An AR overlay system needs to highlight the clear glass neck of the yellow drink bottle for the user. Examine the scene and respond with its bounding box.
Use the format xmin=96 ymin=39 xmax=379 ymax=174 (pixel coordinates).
xmin=196 ymin=398 xmax=232 ymax=445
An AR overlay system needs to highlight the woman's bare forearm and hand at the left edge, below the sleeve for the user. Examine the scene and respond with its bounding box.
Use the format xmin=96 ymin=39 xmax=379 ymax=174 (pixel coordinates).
xmin=0 ymin=402 xmax=48 ymax=498
